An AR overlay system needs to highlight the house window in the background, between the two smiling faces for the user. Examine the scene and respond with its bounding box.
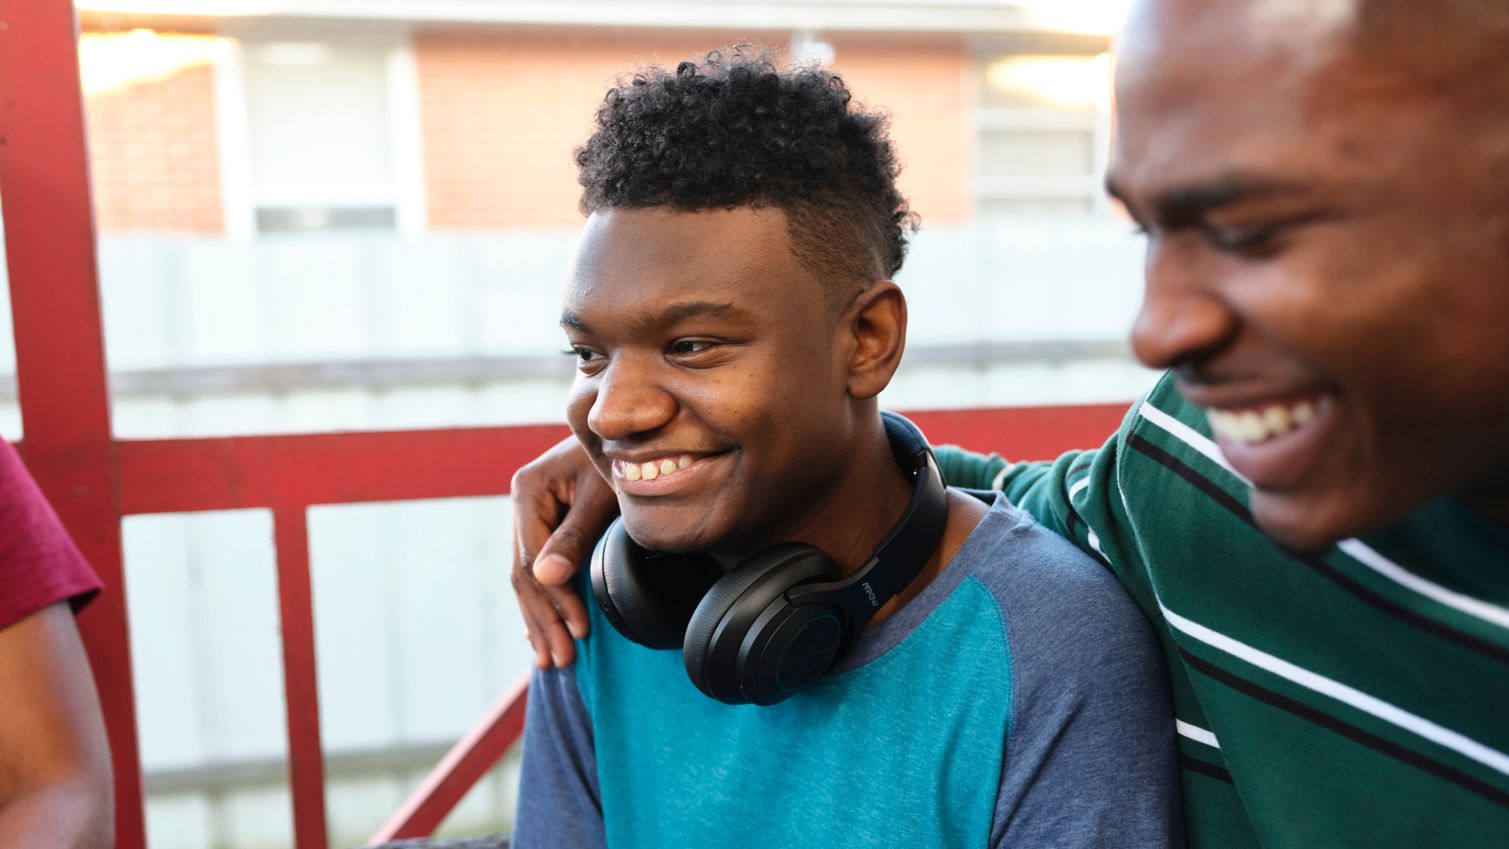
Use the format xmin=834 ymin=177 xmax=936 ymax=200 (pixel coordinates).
xmin=978 ymin=54 xmax=1111 ymax=219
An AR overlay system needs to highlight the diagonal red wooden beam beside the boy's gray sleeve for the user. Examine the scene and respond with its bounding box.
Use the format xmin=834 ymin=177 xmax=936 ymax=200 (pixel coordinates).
xmin=368 ymin=674 xmax=530 ymax=846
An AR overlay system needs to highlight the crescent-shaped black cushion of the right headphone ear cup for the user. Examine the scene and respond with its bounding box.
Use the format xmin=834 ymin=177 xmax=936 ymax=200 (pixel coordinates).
xmin=682 ymin=543 xmax=844 ymax=704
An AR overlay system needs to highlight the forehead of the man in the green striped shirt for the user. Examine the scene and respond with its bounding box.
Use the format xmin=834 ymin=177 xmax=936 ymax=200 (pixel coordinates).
xmin=1112 ymin=0 xmax=1402 ymax=196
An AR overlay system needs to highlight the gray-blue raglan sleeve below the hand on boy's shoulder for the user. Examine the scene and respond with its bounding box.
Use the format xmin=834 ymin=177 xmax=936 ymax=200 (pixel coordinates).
xmin=512 ymin=667 xmax=608 ymax=849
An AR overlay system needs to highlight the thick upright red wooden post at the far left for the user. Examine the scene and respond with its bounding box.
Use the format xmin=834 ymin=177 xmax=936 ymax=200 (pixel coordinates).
xmin=0 ymin=0 xmax=146 ymax=849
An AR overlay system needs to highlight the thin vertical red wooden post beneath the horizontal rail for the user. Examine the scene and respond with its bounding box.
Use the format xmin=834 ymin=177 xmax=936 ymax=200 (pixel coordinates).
xmin=273 ymin=507 xmax=329 ymax=849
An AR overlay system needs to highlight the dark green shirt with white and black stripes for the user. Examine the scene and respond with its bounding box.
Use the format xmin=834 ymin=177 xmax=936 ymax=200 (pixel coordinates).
xmin=939 ymin=375 xmax=1509 ymax=849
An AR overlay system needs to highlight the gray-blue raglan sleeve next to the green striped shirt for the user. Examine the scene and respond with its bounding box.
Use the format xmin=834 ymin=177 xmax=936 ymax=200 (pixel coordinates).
xmin=991 ymin=526 xmax=1185 ymax=849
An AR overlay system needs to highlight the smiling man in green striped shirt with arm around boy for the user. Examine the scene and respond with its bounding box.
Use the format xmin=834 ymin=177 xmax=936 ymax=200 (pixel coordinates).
xmin=515 ymin=0 xmax=1509 ymax=849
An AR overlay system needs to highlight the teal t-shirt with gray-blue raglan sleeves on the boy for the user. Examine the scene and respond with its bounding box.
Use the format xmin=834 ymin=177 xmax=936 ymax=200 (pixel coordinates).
xmin=515 ymin=496 xmax=1182 ymax=849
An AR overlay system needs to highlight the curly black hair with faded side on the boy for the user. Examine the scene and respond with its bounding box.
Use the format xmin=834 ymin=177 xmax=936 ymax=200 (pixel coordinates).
xmin=576 ymin=47 xmax=917 ymax=290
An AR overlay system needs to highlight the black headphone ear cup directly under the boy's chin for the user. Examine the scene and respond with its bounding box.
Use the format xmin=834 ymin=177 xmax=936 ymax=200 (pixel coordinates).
xmin=592 ymin=519 xmax=723 ymax=648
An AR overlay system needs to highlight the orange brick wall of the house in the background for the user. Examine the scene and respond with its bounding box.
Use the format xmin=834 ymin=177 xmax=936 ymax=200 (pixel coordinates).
xmin=88 ymin=29 xmax=973 ymax=232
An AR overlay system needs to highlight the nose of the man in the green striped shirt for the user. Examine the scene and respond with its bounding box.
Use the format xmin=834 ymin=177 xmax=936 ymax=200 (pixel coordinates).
xmin=1132 ymin=240 xmax=1240 ymax=368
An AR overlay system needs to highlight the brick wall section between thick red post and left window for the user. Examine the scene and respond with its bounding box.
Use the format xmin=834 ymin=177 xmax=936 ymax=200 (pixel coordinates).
xmin=86 ymin=50 xmax=225 ymax=232
